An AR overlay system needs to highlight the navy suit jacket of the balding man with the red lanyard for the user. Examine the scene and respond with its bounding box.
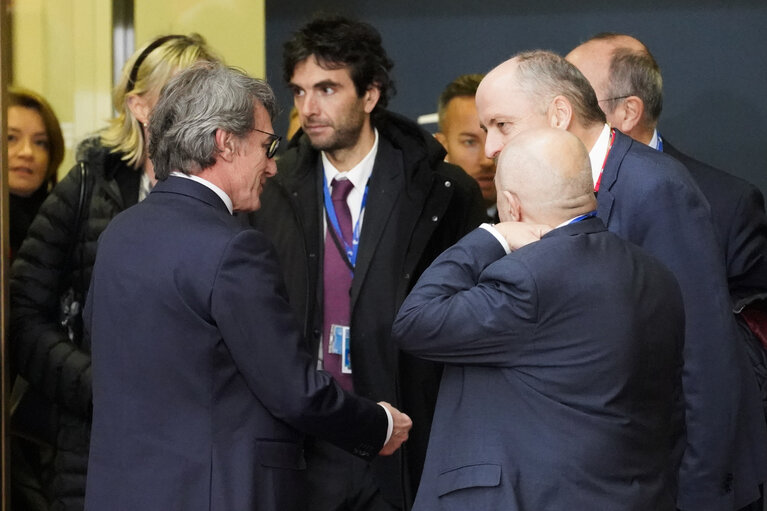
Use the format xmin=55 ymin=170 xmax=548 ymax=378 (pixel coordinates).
xmin=597 ymin=132 xmax=767 ymax=511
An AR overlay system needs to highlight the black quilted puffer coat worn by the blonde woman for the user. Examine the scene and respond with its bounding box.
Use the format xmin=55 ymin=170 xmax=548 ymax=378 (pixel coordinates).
xmin=10 ymin=139 xmax=141 ymax=510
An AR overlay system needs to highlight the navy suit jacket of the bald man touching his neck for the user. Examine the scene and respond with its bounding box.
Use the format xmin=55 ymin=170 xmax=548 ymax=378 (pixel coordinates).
xmin=394 ymin=218 xmax=684 ymax=511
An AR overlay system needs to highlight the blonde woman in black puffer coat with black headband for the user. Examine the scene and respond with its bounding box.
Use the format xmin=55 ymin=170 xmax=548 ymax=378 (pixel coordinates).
xmin=10 ymin=34 xmax=218 ymax=510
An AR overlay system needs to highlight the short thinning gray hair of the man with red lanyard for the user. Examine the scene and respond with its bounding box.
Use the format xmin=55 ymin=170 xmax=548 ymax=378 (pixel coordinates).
xmin=514 ymin=50 xmax=606 ymax=126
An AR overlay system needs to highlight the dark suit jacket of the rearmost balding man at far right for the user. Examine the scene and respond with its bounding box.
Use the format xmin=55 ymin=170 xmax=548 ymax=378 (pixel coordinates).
xmin=663 ymin=139 xmax=767 ymax=311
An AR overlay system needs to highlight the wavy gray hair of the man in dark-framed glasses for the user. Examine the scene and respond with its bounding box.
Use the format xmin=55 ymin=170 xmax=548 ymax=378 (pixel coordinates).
xmin=149 ymin=62 xmax=277 ymax=180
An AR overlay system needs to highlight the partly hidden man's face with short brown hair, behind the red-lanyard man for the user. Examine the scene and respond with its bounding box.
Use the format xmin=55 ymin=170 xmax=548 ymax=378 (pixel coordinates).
xmin=434 ymin=74 xmax=498 ymax=222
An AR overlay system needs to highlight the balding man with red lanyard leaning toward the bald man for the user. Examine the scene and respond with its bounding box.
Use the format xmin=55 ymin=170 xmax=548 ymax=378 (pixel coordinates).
xmin=477 ymin=51 xmax=767 ymax=511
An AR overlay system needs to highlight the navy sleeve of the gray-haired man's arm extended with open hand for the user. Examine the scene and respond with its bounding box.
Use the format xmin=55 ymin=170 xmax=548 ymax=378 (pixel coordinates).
xmin=211 ymin=230 xmax=388 ymax=458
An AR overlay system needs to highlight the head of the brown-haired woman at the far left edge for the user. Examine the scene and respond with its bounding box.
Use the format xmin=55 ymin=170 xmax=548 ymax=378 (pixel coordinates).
xmin=8 ymin=87 xmax=64 ymax=257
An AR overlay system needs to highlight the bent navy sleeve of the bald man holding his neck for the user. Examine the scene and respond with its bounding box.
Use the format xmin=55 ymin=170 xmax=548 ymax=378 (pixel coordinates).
xmin=393 ymin=229 xmax=537 ymax=366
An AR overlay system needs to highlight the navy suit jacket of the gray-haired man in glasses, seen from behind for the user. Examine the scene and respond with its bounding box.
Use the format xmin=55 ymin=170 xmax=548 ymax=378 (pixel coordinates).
xmin=86 ymin=176 xmax=387 ymax=511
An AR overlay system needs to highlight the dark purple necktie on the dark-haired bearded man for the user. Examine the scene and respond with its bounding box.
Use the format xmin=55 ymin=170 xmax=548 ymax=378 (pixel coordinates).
xmin=322 ymin=179 xmax=354 ymax=391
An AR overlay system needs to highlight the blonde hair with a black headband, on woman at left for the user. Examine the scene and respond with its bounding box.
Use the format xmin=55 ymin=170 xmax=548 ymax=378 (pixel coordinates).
xmin=101 ymin=34 xmax=220 ymax=168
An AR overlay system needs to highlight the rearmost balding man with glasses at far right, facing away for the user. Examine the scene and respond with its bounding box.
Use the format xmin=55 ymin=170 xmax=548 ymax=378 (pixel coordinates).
xmin=566 ymin=37 xmax=767 ymax=511
